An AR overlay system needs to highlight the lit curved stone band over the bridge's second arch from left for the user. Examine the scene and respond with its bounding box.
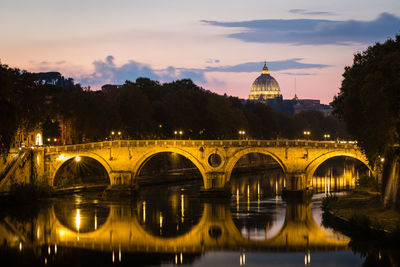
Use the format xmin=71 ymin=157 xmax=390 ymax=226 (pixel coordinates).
xmin=132 ymin=147 xmax=207 ymax=183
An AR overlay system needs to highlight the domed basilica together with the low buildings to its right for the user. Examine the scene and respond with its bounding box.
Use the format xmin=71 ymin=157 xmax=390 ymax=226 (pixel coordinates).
xmin=249 ymin=63 xmax=332 ymax=116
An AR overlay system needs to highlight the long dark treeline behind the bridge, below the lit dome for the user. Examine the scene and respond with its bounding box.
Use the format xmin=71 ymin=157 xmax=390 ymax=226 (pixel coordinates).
xmin=0 ymin=65 xmax=346 ymax=155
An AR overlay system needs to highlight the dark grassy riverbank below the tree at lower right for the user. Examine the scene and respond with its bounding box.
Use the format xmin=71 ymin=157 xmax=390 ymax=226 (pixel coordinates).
xmin=323 ymin=190 xmax=400 ymax=235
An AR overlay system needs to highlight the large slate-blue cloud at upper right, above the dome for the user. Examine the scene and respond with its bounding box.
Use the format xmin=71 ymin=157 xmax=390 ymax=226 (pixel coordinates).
xmin=202 ymin=13 xmax=400 ymax=45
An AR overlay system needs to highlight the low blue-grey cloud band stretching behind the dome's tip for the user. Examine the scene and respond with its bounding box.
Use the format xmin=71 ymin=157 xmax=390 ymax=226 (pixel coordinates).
xmin=77 ymin=56 xmax=328 ymax=86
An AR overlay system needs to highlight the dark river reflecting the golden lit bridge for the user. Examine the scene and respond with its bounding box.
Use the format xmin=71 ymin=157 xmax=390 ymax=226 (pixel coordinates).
xmin=0 ymin=158 xmax=388 ymax=267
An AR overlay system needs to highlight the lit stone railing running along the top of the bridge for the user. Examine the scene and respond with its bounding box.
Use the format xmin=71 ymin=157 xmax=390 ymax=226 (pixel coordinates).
xmin=45 ymin=139 xmax=358 ymax=153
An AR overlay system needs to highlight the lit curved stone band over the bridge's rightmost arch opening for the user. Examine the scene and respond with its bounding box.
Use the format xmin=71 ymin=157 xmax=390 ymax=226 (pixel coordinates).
xmin=305 ymin=150 xmax=375 ymax=179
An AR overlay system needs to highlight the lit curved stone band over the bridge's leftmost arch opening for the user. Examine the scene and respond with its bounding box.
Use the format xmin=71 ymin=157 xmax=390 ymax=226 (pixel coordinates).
xmin=50 ymin=152 xmax=112 ymax=186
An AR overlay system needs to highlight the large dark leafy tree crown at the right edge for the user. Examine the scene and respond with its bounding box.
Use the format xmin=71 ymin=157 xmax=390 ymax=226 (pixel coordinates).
xmin=333 ymin=35 xmax=400 ymax=163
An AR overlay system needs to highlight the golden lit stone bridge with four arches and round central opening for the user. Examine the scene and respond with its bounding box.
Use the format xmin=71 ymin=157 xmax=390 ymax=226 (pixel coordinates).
xmin=36 ymin=140 xmax=374 ymax=190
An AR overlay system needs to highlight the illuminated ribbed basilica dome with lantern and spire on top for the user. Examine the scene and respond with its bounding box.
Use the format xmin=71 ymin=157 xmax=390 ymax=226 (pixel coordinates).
xmin=249 ymin=63 xmax=282 ymax=101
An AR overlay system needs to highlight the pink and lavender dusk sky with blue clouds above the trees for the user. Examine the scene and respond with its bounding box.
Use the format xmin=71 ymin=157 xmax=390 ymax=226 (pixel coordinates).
xmin=0 ymin=0 xmax=400 ymax=104
